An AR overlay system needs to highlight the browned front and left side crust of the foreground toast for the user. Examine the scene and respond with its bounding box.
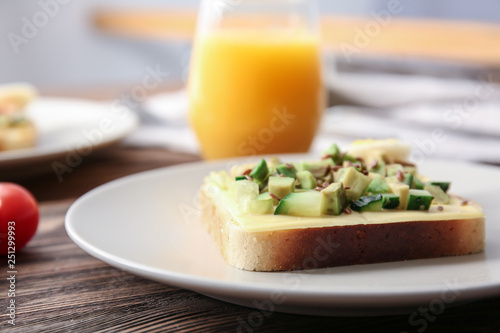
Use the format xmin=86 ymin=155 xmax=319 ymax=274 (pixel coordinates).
xmin=200 ymin=183 xmax=485 ymax=271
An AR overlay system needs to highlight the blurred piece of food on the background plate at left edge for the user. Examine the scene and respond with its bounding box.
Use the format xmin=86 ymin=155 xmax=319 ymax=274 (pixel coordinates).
xmin=0 ymin=83 xmax=37 ymax=151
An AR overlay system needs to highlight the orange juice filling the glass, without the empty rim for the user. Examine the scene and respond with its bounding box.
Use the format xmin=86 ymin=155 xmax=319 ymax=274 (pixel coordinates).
xmin=188 ymin=29 xmax=325 ymax=159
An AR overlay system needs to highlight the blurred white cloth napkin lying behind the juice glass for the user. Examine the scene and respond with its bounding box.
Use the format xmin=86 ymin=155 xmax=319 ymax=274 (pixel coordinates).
xmin=126 ymin=74 xmax=500 ymax=163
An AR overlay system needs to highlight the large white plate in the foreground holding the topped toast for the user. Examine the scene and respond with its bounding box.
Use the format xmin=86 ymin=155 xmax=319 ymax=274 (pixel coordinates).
xmin=66 ymin=156 xmax=500 ymax=316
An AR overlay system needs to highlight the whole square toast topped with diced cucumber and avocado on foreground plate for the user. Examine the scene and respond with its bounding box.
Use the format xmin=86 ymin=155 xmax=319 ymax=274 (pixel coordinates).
xmin=200 ymin=139 xmax=485 ymax=271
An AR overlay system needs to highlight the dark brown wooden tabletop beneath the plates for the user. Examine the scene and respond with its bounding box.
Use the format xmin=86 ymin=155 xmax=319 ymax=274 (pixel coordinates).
xmin=0 ymin=145 xmax=500 ymax=332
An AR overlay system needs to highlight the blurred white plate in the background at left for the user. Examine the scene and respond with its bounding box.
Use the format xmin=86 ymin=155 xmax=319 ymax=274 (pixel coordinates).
xmin=0 ymin=97 xmax=138 ymax=171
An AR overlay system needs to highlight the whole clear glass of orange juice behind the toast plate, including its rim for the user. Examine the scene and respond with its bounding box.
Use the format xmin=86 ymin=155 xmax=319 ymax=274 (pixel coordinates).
xmin=188 ymin=0 xmax=325 ymax=159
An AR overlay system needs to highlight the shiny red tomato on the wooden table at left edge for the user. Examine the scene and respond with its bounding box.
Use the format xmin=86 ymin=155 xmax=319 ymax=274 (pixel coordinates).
xmin=0 ymin=183 xmax=39 ymax=255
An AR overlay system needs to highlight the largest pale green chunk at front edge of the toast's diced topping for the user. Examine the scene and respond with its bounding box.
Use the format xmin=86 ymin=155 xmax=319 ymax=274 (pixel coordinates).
xmin=274 ymin=190 xmax=321 ymax=217
